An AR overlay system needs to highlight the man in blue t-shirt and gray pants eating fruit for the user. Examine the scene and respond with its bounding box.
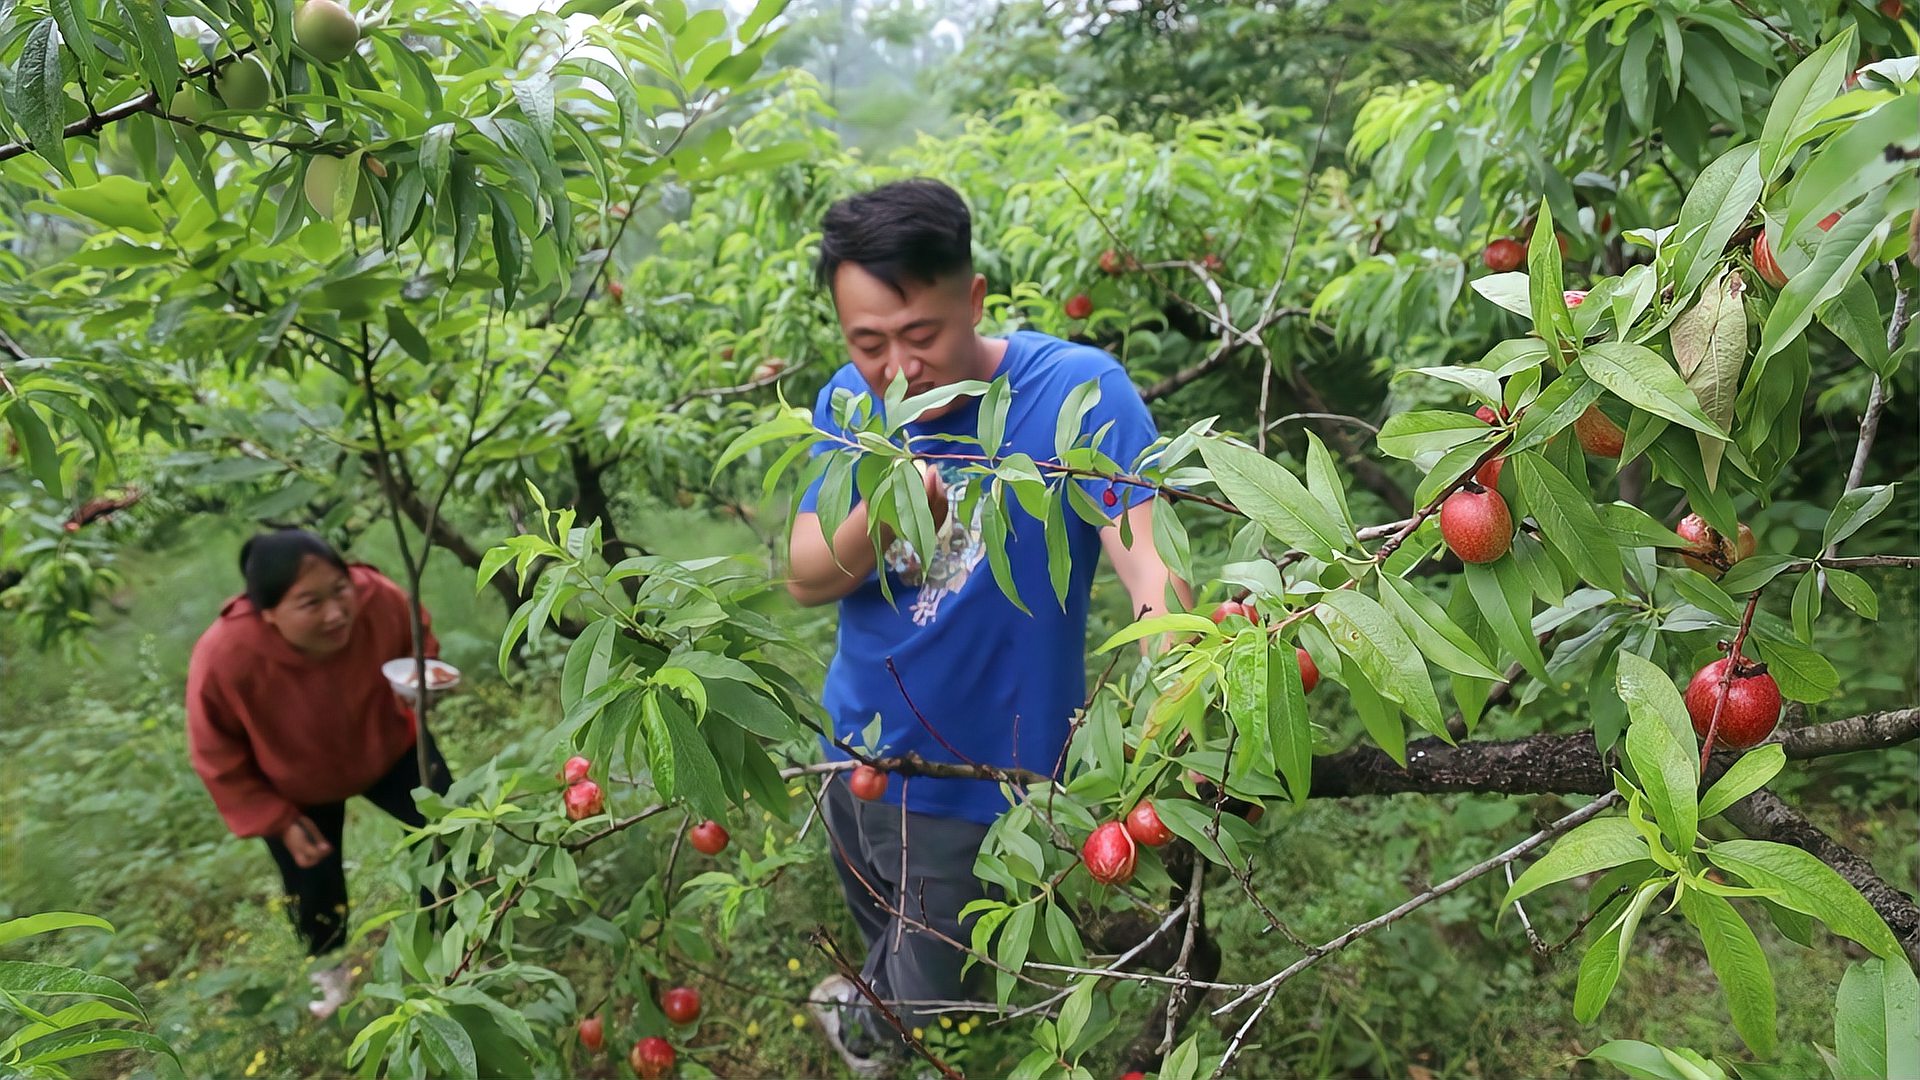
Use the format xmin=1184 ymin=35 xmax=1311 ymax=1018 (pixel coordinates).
xmin=787 ymin=179 xmax=1192 ymax=1072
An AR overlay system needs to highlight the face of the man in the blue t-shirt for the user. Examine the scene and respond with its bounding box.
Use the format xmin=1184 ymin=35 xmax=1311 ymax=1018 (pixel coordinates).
xmin=833 ymin=263 xmax=993 ymax=419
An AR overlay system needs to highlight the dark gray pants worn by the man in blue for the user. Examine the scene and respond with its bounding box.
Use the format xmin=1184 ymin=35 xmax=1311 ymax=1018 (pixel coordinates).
xmin=824 ymin=773 xmax=987 ymax=1030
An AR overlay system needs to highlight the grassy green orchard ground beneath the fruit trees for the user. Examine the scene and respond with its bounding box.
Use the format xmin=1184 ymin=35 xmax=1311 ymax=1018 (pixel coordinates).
xmin=0 ymin=505 xmax=1920 ymax=1080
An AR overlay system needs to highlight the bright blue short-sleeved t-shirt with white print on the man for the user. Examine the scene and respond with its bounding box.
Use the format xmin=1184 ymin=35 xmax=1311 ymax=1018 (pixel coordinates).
xmin=801 ymin=331 xmax=1158 ymax=824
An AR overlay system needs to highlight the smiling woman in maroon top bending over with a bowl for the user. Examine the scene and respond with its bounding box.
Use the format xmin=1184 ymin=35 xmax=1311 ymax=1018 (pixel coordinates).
xmin=186 ymin=528 xmax=451 ymax=1017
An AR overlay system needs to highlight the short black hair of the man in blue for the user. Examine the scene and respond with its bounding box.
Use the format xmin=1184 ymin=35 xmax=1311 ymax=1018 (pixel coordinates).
xmin=814 ymin=177 xmax=973 ymax=296
